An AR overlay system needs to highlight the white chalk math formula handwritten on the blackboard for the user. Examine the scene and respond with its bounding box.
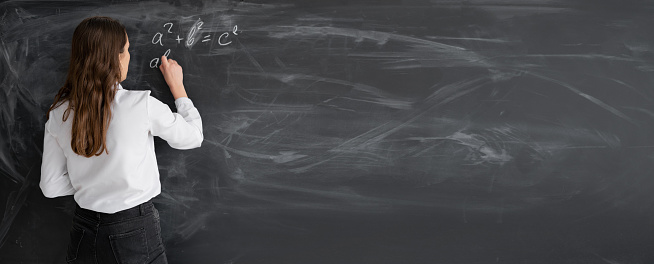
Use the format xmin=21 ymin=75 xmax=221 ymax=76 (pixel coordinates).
xmin=150 ymin=19 xmax=239 ymax=68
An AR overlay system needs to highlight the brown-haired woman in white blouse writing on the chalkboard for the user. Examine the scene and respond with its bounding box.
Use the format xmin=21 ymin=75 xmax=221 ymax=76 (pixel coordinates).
xmin=40 ymin=17 xmax=203 ymax=263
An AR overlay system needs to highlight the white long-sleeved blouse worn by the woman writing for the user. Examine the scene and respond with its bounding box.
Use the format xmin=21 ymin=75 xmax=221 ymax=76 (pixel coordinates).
xmin=39 ymin=84 xmax=204 ymax=213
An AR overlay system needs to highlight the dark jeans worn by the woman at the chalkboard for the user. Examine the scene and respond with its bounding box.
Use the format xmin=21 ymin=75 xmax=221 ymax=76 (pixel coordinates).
xmin=66 ymin=202 xmax=168 ymax=264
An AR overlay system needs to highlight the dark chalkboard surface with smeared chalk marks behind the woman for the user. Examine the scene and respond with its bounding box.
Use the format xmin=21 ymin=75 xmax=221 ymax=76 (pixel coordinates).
xmin=0 ymin=0 xmax=654 ymax=264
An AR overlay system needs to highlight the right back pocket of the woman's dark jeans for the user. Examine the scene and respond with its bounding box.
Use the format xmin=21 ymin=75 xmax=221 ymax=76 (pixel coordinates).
xmin=109 ymin=228 xmax=148 ymax=264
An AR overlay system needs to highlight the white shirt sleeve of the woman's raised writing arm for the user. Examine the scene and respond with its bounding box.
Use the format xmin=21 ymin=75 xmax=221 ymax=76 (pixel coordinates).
xmin=148 ymin=96 xmax=204 ymax=149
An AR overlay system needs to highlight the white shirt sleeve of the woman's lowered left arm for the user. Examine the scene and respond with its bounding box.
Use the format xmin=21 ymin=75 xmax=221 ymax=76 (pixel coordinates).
xmin=39 ymin=118 xmax=75 ymax=198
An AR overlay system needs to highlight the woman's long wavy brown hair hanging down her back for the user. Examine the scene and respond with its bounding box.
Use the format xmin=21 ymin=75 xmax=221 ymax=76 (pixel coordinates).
xmin=48 ymin=17 xmax=127 ymax=157
